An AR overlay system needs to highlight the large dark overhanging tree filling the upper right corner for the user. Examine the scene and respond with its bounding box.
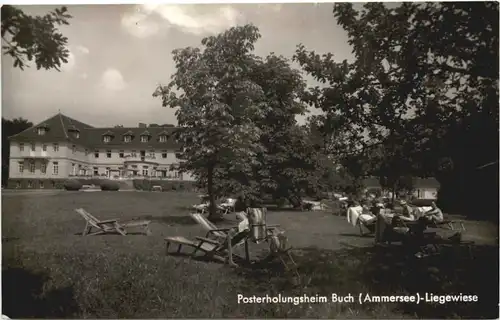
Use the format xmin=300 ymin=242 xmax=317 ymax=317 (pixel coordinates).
xmin=295 ymin=2 xmax=498 ymax=214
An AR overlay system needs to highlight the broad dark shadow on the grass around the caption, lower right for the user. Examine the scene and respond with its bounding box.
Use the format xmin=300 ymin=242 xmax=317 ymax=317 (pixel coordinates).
xmin=236 ymin=246 xmax=499 ymax=319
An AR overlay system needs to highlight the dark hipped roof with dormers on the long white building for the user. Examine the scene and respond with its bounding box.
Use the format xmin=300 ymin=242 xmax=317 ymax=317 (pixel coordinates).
xmin=9 ymin=113 xmax=178 ymax=150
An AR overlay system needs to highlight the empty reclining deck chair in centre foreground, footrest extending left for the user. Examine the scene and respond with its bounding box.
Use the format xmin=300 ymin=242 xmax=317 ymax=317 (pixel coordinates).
xmin=164 ymin=229 xmax=250 ymax=266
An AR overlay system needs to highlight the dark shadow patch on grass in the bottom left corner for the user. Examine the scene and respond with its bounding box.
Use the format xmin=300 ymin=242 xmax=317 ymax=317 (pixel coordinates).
xmin=2 ymin=267 xmax=79 ymax=319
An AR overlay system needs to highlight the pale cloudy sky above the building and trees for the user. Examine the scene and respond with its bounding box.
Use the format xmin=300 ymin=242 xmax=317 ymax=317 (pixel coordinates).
xmin=2 ymin=3 xmax=358 ymax=126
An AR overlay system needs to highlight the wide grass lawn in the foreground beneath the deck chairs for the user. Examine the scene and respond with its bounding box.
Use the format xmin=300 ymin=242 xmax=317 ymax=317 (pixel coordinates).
xmin=2 ymin=192 xmax=498 ymax=318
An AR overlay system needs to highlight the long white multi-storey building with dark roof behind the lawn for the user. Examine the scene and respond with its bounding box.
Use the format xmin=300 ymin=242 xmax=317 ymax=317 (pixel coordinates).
xmin=9 ymin=113 xmax=192 ymax=188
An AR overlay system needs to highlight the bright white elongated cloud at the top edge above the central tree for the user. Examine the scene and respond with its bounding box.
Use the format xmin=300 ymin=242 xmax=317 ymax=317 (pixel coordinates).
xmin=122 ymin=3 xmax=242 ymax=37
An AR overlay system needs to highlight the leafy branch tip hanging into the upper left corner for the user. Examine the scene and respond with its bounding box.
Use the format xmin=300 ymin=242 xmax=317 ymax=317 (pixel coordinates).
xmin=2 ymin=5 xmax=71 ymax=71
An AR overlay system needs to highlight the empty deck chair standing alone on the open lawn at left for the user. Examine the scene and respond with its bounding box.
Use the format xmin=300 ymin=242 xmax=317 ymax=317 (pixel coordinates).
xmin=75 ymin=208 xmax=151 ymax=236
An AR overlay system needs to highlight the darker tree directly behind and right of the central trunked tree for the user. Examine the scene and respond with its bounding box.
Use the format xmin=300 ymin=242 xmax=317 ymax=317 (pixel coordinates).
xmin=252 ymin=53 xmax=324 ymax=207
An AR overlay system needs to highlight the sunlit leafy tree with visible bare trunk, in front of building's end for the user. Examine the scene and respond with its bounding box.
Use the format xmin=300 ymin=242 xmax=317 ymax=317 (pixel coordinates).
xmin=153 ymin=25 xmax=266 ymax=220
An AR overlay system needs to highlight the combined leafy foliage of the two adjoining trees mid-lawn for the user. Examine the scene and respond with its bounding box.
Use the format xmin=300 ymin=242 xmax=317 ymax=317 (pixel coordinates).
xmin=154 ymin=25 xmax=332 ymax=218
